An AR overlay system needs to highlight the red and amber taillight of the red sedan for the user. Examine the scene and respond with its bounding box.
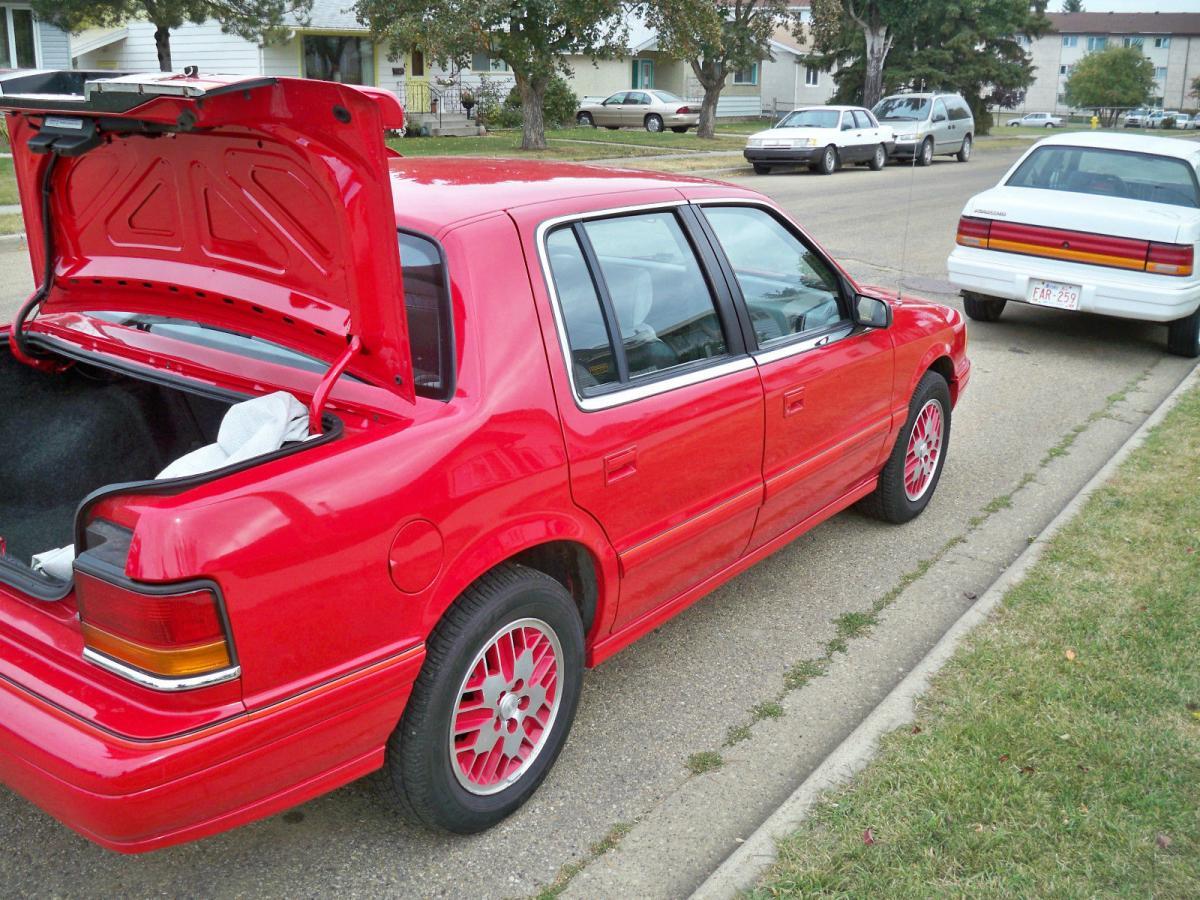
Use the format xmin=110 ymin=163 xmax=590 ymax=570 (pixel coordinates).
xmin=76 ymin=571 xmax=233 ymax=678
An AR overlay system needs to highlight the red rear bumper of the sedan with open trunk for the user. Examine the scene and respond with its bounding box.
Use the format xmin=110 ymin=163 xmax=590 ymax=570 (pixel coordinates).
xmin=0 ymin=646 xmax=425 ymax=853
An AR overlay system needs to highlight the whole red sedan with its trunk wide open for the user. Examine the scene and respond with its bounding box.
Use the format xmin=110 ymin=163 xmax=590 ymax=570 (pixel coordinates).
xmin=0 ymin=72 xmax=970 ymax=852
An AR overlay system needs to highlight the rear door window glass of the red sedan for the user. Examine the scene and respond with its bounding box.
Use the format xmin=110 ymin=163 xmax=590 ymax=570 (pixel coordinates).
xmin=546 ymin=212 xmax=728 ymax=395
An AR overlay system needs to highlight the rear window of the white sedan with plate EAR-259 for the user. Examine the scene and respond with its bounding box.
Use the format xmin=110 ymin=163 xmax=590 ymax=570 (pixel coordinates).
xmin=1008 ymin=146 xmax=1200 ymax=209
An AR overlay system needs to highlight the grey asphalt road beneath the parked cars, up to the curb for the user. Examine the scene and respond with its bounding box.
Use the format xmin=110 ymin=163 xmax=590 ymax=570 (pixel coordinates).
xmin=0 ymin=144 xmax=1190 ymax=898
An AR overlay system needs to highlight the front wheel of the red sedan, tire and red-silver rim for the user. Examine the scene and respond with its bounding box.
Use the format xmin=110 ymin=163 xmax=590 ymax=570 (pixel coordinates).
xmin=859 ymin=372 xmax=950 ymax=524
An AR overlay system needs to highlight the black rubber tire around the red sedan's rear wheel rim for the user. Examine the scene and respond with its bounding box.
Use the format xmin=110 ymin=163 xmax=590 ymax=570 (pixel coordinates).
xmin=379 ymin=564 xmax=583 ymax=834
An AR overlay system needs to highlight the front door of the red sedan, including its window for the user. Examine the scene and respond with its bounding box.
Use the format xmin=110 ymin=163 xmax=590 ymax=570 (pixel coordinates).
xmin=703 ymin=204 xmax=894 ymax=548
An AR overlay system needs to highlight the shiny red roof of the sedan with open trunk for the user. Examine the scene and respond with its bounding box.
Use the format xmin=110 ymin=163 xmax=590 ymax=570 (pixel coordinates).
xmin=388 ymin=158 xmax=718 ymax=234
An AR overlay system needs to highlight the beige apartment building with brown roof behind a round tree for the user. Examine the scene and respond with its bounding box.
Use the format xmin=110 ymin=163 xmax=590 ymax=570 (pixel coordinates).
xmin=1018 ymin=12 xmax=1200 ymax=113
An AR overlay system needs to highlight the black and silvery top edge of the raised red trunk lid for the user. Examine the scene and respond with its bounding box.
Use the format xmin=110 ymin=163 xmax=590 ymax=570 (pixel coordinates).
xmin=0 ymin=70 xmax=278 ymax=115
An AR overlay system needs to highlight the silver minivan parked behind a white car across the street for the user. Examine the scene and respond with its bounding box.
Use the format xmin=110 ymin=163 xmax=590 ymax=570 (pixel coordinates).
xmin=871 ymin=94 xmax=974 ymax=166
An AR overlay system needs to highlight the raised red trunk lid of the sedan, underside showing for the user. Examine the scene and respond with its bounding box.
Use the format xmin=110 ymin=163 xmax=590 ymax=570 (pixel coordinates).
xmin=0 ymin=71 xmax=414 ymax=401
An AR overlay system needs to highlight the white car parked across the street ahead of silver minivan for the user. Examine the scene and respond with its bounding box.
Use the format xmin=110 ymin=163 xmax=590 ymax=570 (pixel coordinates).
xmin=743 ymin=107 xmax=895 ymax=175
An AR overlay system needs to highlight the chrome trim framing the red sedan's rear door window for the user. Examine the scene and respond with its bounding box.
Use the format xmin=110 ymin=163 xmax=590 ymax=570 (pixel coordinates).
xmin=535 ymin=199 xmax=755 ymax=413
